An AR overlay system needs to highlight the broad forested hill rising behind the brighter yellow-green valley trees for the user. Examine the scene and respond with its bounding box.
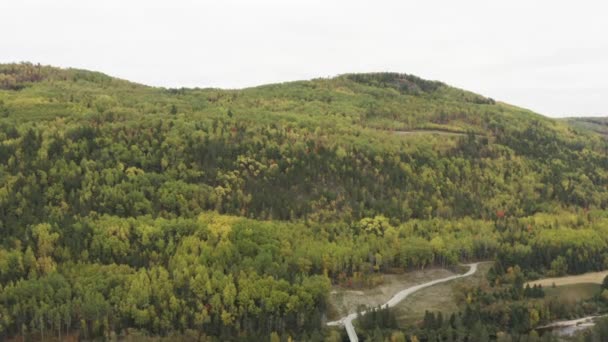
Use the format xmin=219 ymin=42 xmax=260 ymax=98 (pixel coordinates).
xmin=0 ymin=64 xmax=607 ymax=226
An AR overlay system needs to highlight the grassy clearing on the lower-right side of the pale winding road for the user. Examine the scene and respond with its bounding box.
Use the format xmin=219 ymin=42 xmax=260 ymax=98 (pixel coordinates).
xmin=393 ymin=262 xmax=492 ymax=326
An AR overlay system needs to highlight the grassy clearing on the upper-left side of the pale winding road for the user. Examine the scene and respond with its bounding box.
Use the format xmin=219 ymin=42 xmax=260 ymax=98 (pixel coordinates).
xmin=328 ymin=268 xmax=455 ymax=320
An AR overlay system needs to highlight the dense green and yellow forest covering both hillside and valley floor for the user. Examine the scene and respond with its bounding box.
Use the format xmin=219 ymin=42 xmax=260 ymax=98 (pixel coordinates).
xmin=0 ymin=63 xmax=608 ymax=341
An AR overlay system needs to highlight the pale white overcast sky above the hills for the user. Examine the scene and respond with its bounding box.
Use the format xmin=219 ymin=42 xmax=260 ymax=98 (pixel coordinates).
xmin=0 ymin=0 xmax=608 ymax=117
